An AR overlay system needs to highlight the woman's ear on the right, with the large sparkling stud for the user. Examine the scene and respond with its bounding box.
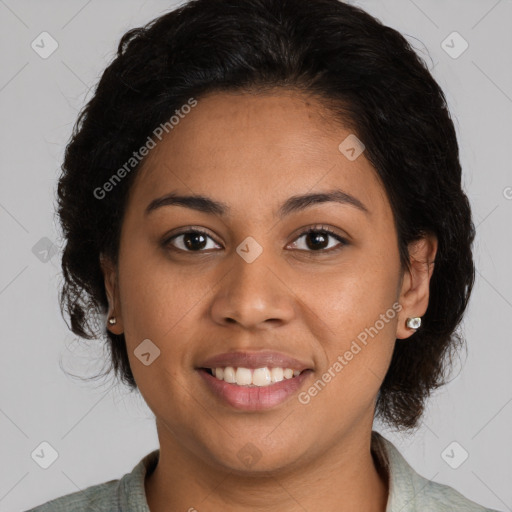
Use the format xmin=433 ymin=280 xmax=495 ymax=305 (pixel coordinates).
xmin=396 ymin=234 xmax=438 ymax=339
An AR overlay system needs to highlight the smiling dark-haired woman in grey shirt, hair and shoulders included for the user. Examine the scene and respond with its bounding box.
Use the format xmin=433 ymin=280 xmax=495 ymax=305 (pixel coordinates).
xmin=27 ymin=0 xmax=500 ymax=512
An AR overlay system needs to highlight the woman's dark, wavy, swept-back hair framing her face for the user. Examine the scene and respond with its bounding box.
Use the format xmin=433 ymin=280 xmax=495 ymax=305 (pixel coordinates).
xmin=57 ymin=0 xmax=475 ymax=429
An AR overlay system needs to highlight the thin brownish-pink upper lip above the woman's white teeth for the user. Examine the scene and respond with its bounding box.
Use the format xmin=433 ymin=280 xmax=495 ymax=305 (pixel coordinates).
xmin=200 ymin=351 xmax=311 ymax=371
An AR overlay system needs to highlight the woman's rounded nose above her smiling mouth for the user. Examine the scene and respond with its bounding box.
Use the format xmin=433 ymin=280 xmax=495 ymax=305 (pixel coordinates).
xmin=210 ymin=251 xmax=295 ymax=329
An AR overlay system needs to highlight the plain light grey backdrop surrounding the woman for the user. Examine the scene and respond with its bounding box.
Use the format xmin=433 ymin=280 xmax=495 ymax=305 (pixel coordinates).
xmin=0 ymin=0 xmax=512 ymax=511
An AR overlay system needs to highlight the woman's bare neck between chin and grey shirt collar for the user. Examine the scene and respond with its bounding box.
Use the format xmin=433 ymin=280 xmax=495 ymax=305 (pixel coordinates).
xmin=145 ymin=427 xmax=388 ymax=512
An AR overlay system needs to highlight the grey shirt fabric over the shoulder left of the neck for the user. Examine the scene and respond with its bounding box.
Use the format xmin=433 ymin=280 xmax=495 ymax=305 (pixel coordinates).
xmin=26 ymin=450 xmax=160 ymax=512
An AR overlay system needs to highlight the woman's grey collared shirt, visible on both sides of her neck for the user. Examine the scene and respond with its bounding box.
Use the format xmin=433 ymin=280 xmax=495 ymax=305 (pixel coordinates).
xmin=26 ymin=431 xmax=498 ymax=512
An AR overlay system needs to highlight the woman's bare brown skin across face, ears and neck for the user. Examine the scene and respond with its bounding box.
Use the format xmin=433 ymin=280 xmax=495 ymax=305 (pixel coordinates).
xmin=102 ymin=90 xmax=437 ymax=512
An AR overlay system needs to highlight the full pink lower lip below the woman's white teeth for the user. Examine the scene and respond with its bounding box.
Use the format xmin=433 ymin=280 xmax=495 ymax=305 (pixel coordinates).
xmin=198 ymin=368 xmax=312 ymax=411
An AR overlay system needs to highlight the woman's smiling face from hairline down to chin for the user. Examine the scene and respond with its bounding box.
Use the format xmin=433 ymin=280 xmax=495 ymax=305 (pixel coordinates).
xmin=106 ymin=91 xmax=428 ymax=471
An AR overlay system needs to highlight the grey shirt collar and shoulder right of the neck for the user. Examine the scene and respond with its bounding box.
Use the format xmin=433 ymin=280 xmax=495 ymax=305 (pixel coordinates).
xmin=372 ymin=432 xmax=498 ymax=512
